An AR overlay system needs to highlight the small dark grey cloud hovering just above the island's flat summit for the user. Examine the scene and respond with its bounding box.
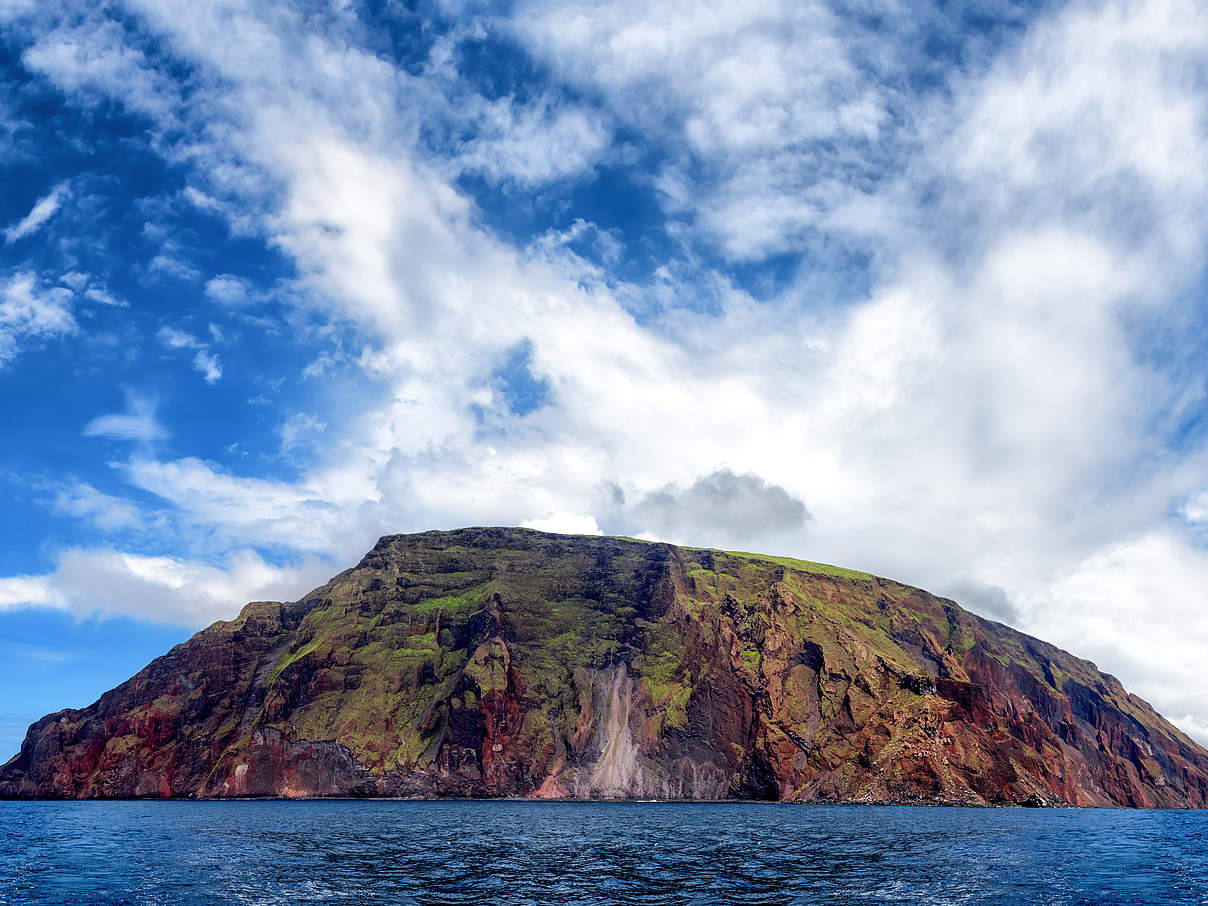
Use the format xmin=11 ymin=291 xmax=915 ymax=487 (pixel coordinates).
xmin=629 ymin=469 xmax=811 ymax=544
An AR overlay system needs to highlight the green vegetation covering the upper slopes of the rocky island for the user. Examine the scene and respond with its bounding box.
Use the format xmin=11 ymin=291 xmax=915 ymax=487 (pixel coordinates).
xmin=181 ymin=529 xmax=1198 ymax=802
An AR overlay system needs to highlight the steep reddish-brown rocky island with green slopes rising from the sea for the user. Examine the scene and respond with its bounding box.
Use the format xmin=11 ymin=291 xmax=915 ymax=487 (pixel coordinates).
xmin=0 ymin=528 xmax=1208 ymax=808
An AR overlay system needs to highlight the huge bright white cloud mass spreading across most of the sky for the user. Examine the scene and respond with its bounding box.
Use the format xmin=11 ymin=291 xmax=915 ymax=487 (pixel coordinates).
xmin=7 ymin=0 xmax=1208 ymax=748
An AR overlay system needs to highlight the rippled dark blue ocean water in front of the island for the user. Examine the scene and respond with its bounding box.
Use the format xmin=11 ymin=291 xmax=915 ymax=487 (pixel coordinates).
xmin=0 ymin=801 xmax=1208 ymax=906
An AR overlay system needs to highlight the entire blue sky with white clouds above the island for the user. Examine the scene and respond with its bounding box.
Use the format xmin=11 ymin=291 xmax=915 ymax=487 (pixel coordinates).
xmin=0 ymin=0 xmax=1208 ymax=759
